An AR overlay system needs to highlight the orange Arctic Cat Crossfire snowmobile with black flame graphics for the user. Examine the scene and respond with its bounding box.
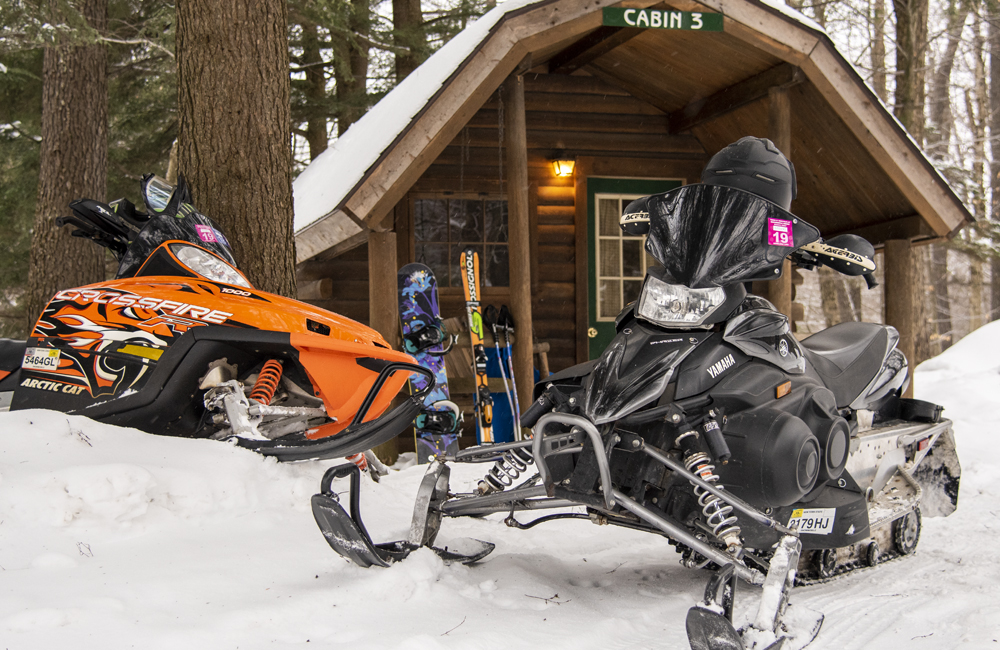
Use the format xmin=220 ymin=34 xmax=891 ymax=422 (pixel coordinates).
xmin=0 ymin=175 xmax=434 ymax=460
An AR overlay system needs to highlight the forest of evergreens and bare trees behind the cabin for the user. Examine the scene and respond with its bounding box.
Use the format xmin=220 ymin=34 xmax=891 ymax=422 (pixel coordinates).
xmin=0 ymin=0 xmax=1000 ymax=363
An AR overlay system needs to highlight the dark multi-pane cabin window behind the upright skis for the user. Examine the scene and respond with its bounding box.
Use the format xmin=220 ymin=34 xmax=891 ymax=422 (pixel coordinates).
xmin=413 ymin=197 xmax=510 ymax=288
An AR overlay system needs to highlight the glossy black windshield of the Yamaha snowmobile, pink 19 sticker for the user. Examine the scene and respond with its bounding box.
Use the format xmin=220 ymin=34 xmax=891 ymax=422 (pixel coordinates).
xmin=640 ymin=184 xmax=819 ymax=289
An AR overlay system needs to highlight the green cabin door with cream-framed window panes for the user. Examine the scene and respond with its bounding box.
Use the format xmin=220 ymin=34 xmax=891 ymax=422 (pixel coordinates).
xmin=587 ymin=178 xmax=681 ymax=359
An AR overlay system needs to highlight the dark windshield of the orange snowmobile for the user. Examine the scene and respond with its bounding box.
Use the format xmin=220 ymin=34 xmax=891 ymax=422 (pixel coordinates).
xmin=116 ymin=203 xmax=236 ymax=278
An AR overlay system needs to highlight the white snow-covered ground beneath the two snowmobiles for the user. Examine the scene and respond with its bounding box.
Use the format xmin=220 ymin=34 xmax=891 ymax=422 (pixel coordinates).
xmin=0 ymin=323 xmax=1000 ymax=650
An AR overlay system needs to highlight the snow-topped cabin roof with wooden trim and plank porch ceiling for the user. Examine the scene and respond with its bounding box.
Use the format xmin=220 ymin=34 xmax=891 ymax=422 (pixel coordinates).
xmin=293 ymin=0 xmax=972 ymax=261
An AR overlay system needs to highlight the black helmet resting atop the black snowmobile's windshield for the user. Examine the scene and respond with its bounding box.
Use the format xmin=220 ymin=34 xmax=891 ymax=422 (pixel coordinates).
xmin=701 ymin=136 xmax=795 ymax=211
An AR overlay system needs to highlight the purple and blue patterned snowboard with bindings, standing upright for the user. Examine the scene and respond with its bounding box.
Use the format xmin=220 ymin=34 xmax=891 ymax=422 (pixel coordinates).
xmin=396 ymin=264 xmax=462 ymax=463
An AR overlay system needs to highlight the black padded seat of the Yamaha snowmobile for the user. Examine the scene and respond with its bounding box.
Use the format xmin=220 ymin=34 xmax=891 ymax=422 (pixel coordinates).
xmin=800 ymin=323 xmax=889 ymax=408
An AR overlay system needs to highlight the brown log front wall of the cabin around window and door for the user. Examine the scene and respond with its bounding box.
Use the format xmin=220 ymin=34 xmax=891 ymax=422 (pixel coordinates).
xmin=299 ymin=72 xmax=706 ymax=372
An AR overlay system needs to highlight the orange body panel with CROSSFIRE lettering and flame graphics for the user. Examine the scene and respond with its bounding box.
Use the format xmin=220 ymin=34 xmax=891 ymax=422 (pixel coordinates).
xmin=29 ymin=276 xmax=413 ymax=437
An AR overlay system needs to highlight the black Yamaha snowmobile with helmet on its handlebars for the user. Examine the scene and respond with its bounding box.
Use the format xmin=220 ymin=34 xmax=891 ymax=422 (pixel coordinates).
xmin=313 ymin=138 xmax=960 ymax=650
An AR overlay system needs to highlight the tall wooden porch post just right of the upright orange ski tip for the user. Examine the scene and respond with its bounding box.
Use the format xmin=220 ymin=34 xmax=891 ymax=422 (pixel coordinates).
xmin=502 ymin=74 xmax=535 ymax=428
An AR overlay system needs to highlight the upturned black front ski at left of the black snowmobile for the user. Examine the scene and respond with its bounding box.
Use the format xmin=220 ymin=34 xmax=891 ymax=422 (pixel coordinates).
xmin=312 ymin=463 xmax=494 ymax=568
